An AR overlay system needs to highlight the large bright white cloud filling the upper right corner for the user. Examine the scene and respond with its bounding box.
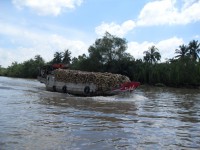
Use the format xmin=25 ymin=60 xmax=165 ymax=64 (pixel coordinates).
xmin=137 ymin=0 xmax=200 ymax=26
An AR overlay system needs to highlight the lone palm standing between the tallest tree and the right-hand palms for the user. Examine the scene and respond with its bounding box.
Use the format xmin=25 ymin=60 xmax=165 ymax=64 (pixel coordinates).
xmin=143 ymin=45 xmax=161 ymax=64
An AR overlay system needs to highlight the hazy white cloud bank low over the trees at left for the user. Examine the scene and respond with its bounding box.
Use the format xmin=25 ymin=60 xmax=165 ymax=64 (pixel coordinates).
xmin=0 ymin=24 xmax=89 ymax=67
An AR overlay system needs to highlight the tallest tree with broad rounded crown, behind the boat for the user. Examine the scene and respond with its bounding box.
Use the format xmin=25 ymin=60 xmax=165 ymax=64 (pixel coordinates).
xmin=88 ymin=32 xmax=130 ymax=72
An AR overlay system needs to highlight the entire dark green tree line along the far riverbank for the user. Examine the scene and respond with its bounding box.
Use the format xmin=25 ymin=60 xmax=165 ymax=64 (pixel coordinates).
xmin=0 ymin=32 xmax=200 ymax=87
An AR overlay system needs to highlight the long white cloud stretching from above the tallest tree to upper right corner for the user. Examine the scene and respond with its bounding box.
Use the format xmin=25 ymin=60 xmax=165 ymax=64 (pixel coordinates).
xmin=95 ymin=0 xmax=200 ymax=37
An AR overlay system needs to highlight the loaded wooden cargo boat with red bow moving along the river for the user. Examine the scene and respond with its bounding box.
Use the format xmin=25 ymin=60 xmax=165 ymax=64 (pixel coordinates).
xmin=38 ymin=64 xmax=140 ymax=96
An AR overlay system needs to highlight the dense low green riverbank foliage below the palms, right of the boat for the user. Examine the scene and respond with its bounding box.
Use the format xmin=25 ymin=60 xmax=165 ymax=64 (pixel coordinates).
xmin=134 ymin=60 xmax=200 ymax=87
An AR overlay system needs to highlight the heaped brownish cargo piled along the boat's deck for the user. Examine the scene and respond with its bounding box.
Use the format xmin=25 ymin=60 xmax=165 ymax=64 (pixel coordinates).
xmin=54 ymin=69 xmax=130 ymax=91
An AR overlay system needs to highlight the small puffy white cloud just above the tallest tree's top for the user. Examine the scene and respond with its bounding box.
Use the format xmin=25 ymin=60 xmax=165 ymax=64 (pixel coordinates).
xmin=95 ymin=20 xmax=135 ymax=37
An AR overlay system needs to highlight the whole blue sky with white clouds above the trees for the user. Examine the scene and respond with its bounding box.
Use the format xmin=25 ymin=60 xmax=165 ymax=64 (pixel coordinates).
xmin=0 ymin=0 xmax=200 ymax=67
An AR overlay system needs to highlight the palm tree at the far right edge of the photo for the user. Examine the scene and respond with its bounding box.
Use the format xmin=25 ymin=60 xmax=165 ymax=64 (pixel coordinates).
xmin=188 ymin=40 xmax=200 ymax=61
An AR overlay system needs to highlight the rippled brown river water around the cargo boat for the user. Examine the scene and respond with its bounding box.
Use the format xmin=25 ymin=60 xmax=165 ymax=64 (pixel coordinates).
xmin=0 ymin=77 xmax=200 ymax=150
